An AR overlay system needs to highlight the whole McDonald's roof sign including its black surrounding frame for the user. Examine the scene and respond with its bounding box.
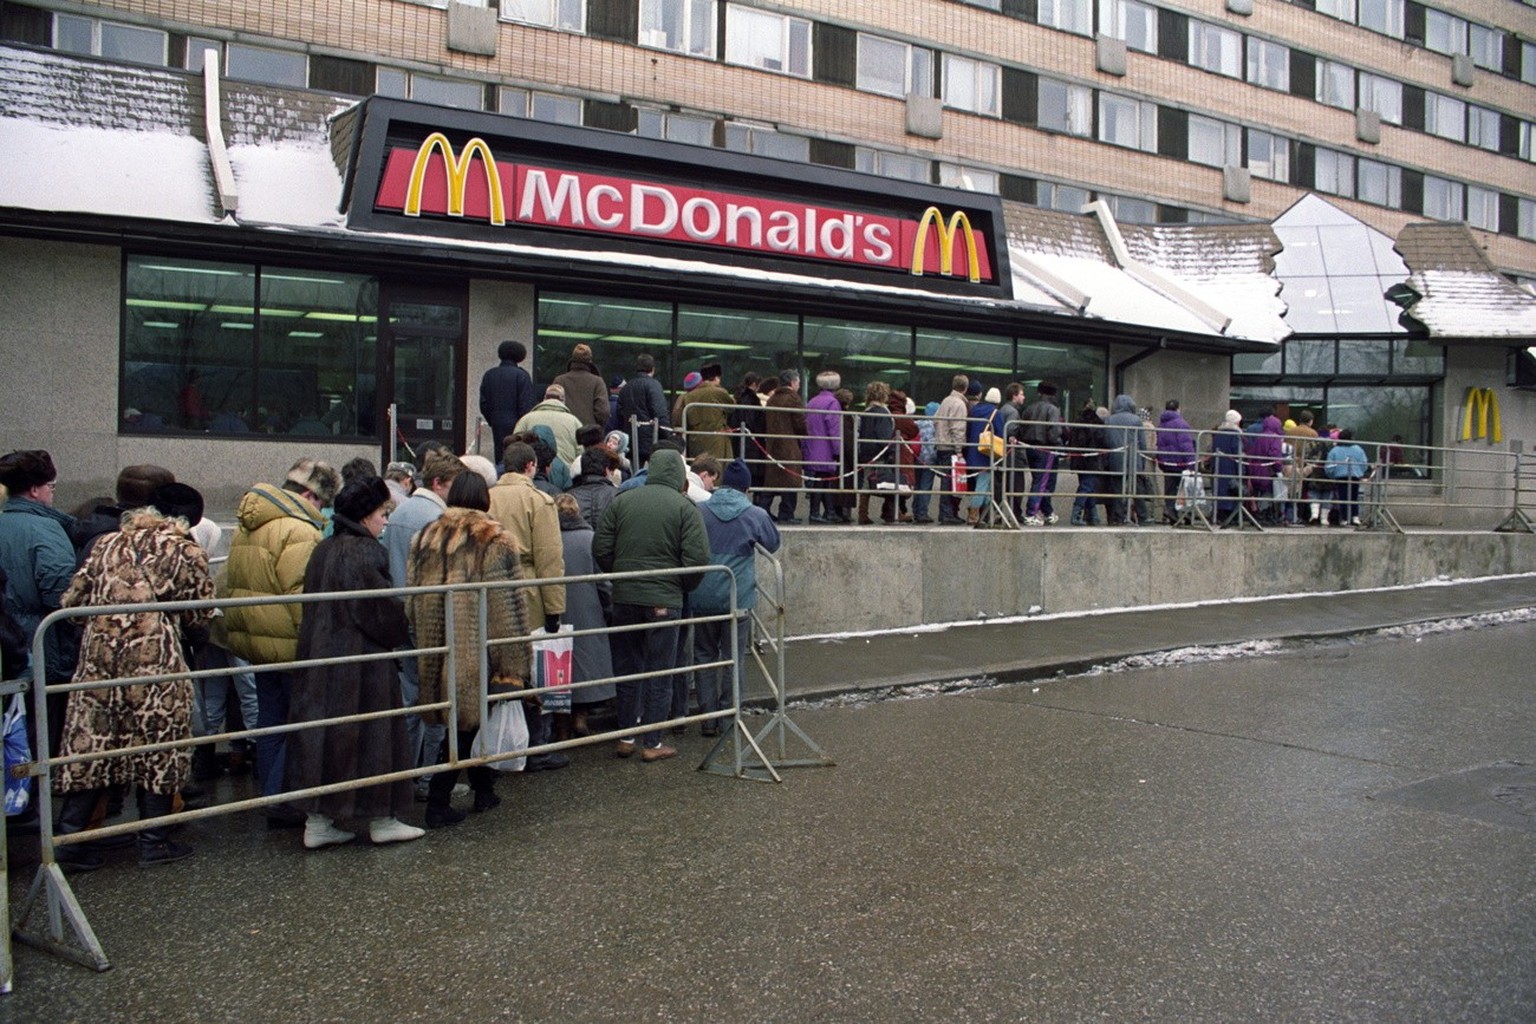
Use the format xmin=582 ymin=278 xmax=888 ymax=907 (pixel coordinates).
xmin=349 ymin=100 xmax=1011 ymax=295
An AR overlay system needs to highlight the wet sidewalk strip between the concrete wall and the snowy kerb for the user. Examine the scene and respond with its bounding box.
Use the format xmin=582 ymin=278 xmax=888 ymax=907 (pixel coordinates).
xmin=785 ymin=574 xmax=1536 ymax=699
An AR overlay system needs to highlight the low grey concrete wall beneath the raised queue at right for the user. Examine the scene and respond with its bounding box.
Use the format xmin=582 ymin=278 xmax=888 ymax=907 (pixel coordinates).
xmin=774 ymin=528 xmax=1536 ymax=636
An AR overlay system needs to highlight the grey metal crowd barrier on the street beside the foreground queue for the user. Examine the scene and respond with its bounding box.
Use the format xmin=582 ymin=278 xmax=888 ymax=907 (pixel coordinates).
xmin=9 ymin=564 xmax=833 ymax=978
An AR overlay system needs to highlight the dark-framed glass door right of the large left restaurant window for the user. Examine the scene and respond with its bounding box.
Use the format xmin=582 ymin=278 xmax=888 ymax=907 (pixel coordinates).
xmin=379 ymin=281 xmax=468 ymax=462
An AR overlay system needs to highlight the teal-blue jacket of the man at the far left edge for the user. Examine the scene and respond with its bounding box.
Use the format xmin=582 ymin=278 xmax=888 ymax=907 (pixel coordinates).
xmin=0 ymin=497 xmax=78 ymax=682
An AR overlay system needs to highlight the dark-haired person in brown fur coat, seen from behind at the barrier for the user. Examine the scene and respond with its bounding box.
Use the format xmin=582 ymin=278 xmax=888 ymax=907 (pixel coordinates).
xmin=406 ymin=473 xmax=528 ymax=827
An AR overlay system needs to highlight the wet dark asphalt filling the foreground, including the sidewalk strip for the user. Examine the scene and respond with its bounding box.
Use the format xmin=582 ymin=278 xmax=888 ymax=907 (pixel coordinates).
xmin=0 ymin=579 xmax=1536 ymax=1024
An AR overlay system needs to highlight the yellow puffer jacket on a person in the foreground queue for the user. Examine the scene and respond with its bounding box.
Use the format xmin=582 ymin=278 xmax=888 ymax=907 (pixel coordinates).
xmin=221 ymin=484 xmax=326 ymax=665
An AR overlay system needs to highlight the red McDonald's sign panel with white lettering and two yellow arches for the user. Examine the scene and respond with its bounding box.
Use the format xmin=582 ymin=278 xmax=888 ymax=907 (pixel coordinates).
xmin=373 ymin=132 xmax=991 ymax=284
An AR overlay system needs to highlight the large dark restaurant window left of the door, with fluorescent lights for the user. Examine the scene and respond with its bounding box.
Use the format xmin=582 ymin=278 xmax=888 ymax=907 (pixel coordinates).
xmin=123 ymin=256 xmax=378 ymax=438
